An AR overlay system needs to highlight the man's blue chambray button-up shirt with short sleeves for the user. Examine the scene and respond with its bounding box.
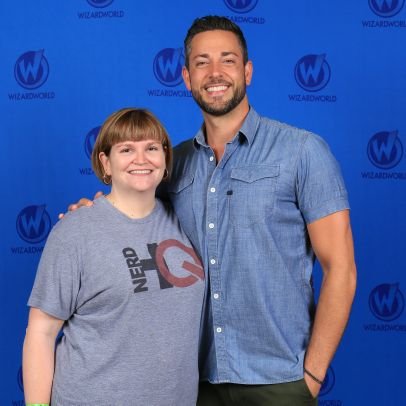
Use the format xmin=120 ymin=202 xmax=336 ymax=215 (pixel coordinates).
xmin=169 ymin=108 xmax=349 ymax=384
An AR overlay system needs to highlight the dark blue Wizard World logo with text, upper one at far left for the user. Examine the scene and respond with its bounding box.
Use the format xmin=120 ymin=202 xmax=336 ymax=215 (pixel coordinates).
xmin=9 ymin=49 xmax=55 ymax=100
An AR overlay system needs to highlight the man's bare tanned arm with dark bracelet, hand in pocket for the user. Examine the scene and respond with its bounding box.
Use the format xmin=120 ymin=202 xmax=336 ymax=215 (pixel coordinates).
xmin=304 ymin=210 xmax=356 ymax=396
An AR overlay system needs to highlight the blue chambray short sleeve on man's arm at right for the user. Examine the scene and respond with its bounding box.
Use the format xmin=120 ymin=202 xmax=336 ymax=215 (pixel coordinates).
xmin=296 ymin=133 xmax=349 ymax=224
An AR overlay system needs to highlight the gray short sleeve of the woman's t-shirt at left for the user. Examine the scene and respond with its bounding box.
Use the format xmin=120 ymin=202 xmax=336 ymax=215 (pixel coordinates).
xmin=28 ymin=223 xmax=80 ymax=320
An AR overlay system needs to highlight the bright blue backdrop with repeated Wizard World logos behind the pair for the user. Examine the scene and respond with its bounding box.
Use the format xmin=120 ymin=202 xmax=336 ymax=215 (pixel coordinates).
xmin=0 ymin=0 xmax=406 ymax=406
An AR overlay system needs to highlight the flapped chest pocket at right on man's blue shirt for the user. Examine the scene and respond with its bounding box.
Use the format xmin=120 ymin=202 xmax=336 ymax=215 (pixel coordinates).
xmin=227 ymin=165 xmax=279 ymax=227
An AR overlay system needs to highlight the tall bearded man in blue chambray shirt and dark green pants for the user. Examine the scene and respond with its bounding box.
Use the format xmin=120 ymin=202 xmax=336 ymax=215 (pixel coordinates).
xmin=72 ymin=16 xmax=356 ymax=406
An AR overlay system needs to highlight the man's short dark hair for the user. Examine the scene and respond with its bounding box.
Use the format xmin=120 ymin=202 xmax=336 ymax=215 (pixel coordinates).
xmin=184 ymin=16 xmax=248 ymax=69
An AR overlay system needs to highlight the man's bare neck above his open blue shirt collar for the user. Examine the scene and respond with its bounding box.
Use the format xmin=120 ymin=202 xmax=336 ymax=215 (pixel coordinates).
xmin=203 ymin=96 xmax=249 ymax=162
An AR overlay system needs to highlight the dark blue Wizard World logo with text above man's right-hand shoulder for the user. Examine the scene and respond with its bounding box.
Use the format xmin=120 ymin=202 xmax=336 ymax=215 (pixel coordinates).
xmin=289 ymin=54 xmax=337 ymax=102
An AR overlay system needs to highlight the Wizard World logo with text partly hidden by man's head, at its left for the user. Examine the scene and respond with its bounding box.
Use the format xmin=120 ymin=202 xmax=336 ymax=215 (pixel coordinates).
xmin=148 ymin=48 xmax=192 ymax=97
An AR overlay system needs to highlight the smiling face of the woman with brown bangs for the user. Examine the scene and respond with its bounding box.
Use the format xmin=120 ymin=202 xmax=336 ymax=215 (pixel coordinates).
xmin=99 ymin=140 xmax=166 ymax=194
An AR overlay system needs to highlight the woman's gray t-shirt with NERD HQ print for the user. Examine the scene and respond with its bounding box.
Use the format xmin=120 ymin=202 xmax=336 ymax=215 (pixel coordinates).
xmin=28 ymin=197 xmax=204 ymax=406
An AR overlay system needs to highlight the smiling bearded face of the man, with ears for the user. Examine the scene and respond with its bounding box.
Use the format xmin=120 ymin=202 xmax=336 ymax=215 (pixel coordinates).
xmin=183 ymin=30 xmax=252 ymax=116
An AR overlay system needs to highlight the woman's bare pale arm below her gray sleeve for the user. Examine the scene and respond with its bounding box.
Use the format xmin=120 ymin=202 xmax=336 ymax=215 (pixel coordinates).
xmin=23 ymin=307 xmax=64 ymax=404
